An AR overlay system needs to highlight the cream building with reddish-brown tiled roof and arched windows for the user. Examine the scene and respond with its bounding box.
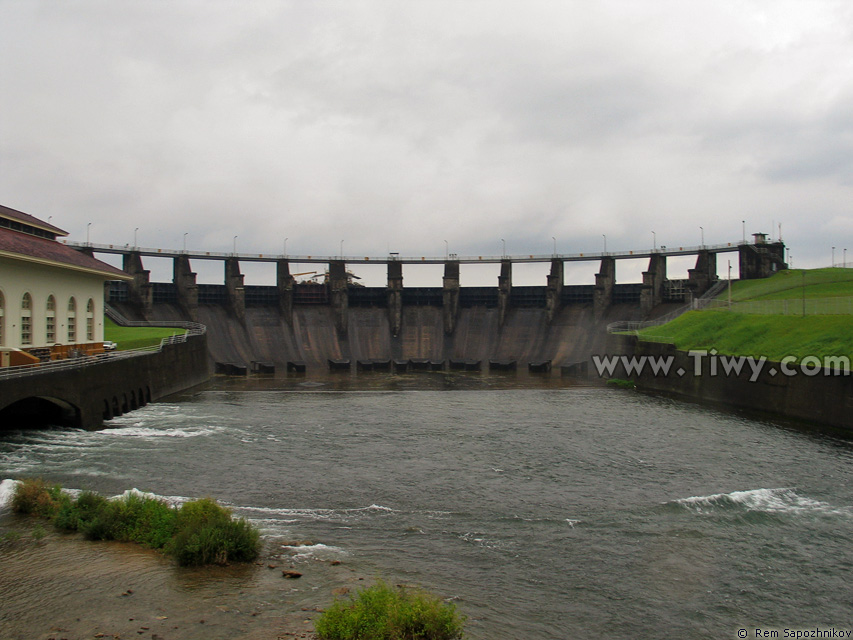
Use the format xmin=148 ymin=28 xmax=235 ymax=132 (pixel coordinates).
xmin=0 ymin=205 xmax=131 ymax=366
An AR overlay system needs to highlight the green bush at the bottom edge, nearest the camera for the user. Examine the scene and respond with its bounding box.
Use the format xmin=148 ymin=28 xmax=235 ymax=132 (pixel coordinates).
xmin=314 ymin=581 xmax=465 ymax=640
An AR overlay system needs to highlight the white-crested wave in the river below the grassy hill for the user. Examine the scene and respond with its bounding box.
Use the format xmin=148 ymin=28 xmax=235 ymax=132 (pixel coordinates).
xmin=675 ymin=487 xmax=853 ymax=516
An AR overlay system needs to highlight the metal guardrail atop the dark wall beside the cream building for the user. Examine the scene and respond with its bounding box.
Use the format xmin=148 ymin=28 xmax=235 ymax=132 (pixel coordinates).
xmin=0 ymin=305 xmax=207 ymax=380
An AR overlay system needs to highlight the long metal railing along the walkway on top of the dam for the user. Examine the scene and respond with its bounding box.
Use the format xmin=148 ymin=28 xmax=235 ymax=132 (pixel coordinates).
xmin=62 ymin=240 xmax=747 ymax=264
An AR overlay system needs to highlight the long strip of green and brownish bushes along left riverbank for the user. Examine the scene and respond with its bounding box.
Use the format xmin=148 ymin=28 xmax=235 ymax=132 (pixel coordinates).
xmin=11 ymin=478 xmax=260 ymax=566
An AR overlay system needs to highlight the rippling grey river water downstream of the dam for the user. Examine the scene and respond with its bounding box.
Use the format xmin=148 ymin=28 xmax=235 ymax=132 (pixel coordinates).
xmin=0 ymin=383 xmax=853 ymax=640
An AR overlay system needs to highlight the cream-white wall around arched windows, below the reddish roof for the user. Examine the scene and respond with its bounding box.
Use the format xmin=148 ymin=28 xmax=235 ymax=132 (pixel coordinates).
xmin=0 ymin=258 xmax=106 ymax=349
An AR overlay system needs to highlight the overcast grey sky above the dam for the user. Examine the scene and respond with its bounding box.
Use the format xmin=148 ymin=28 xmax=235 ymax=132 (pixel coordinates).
xmin=0 ymin=0 xmax=853 ymax=286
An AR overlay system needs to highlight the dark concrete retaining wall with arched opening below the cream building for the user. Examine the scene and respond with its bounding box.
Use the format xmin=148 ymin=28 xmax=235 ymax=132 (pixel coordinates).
xmin=0 ymin=335 xmax=209 ymax=428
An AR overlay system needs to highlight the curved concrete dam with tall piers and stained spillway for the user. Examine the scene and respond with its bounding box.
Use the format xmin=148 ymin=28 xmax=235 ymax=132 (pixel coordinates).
xmin=80 ymin=234 xmax=786 ymax=372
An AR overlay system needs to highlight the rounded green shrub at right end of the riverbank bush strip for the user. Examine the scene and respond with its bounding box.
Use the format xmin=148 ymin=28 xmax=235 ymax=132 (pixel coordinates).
xmin=167 ymin=498 xmax=260 ymax=566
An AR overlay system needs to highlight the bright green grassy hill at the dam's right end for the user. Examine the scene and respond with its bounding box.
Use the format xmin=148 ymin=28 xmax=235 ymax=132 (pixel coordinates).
xmin=640 ymin=269 xmax=853 ymax=361
